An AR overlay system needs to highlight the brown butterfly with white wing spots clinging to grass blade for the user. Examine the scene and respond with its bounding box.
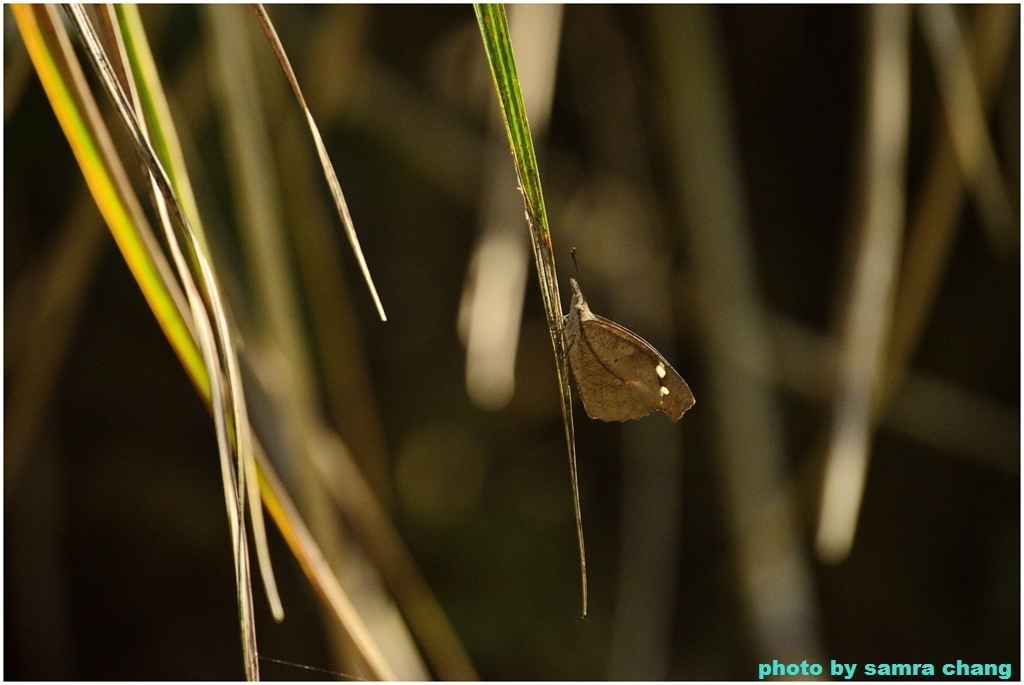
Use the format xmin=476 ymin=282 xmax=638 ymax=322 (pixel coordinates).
xmin=563 ymin=279 xmax=694 ymax=423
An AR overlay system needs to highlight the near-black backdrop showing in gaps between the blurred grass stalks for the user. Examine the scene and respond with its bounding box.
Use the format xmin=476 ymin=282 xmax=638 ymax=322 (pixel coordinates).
xmin=4 ymin=5 xmax=1021 ymax=680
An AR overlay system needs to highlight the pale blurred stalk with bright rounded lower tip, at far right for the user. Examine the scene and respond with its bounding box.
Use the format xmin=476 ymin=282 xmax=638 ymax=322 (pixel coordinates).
xmin=816 ymin=5 xmax=910 ymax=563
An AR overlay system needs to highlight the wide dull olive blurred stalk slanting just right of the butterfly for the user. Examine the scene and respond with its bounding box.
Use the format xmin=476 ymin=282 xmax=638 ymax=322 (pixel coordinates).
xmin=653 ymin=5 xmax=822 ymax=661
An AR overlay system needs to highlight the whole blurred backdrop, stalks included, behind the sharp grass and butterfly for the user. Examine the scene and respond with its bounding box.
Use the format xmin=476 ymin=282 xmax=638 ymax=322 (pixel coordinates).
xmin=3 ymin=5 xmax=1021 ymax=680
